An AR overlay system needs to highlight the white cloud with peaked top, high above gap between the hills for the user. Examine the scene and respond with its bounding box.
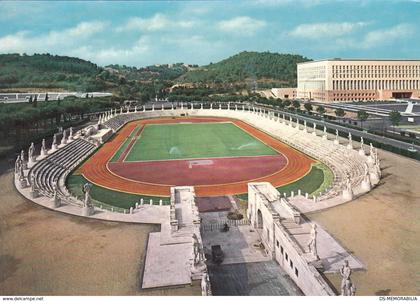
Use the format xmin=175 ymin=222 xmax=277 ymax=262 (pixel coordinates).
xmin=115 ymin=14 xmax=195 ymax=32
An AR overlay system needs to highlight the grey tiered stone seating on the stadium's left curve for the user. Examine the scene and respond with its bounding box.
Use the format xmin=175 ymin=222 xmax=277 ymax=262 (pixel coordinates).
xmin=29 ymin=138 xmax=95 ymax=204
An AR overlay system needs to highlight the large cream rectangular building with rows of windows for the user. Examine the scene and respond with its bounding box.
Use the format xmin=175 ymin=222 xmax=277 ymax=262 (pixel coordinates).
xmin=297 ymin=59 xmax=420 ymax=102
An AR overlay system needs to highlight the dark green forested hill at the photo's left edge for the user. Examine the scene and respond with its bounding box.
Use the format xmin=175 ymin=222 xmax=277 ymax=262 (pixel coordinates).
xmin=0 ymin=54 xmax=103 ymax=91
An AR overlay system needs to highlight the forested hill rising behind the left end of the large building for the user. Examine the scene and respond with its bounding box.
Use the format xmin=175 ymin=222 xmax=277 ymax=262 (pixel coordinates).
xmin=178 ymin=51 xmax=310 ymax=86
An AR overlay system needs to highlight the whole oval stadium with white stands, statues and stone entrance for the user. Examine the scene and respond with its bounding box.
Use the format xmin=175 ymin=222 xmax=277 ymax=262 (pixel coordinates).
xmin=15 ymin=103 xmax=381 ymax=295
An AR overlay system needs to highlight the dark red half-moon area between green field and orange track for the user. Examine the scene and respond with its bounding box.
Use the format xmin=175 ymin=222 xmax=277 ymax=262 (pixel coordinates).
xmin=108 ymin=155 xmax=287 ymax=186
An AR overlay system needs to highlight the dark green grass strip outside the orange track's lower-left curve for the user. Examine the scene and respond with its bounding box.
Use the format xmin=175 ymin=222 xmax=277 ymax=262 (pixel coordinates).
xmin=67 ymin=174 xmax=170 ymax=209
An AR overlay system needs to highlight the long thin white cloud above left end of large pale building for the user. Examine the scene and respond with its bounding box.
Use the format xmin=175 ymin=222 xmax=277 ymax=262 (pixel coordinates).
xmin=290 ymin=22 xmax=368 ymax=39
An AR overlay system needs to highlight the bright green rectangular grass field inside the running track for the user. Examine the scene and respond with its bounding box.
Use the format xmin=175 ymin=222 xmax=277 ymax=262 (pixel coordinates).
xmin=125 ymin=123 xmax=277 ymax=161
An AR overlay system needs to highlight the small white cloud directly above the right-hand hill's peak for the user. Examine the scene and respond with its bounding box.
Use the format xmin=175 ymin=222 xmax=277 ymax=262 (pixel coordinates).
xmin=217 ymin=16 xmax=267 ymax=35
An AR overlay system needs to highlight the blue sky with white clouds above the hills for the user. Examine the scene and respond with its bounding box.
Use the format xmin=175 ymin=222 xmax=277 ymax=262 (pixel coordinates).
xmin=0 ymin=0 xmax=420 ymax=67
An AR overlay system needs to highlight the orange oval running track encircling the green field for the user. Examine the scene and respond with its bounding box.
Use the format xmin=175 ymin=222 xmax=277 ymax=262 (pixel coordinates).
xmin=80 ymin=117 xmax=315 ymax=196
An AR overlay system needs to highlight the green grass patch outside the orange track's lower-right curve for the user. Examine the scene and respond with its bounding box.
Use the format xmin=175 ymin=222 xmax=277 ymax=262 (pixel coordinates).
xmin=237 ymin=163 xmax=333 ymax=200
